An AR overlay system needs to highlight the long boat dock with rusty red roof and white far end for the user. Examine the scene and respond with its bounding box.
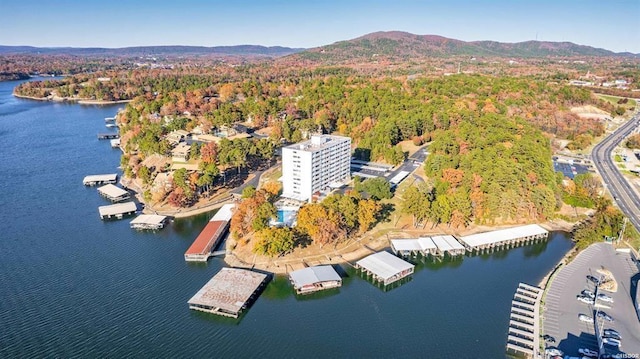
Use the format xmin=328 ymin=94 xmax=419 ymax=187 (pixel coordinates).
xmin=184 ymin=204 xmax=234 ymax=262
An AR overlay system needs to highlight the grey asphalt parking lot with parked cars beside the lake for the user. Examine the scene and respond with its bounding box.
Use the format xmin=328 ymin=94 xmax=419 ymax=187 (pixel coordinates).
xmin=542 ymin=243 xmax=640 ymax=356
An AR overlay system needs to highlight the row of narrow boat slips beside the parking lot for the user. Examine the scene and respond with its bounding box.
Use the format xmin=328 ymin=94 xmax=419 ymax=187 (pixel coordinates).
xmin=507 ymin=283 xmax=542 ymax=358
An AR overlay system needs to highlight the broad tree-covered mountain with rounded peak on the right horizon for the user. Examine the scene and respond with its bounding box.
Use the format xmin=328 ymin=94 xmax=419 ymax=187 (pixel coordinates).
xmin=292 ymin=31 xmax=637 ymax=62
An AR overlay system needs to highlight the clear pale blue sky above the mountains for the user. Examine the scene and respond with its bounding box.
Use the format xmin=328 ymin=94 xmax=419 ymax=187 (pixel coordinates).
xmin=0 ymin=0 xmax=640 ymax=53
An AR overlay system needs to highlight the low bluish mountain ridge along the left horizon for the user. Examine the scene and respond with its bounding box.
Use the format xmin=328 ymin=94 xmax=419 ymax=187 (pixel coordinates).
xmin=0 ymin=45 xmax=304 ymax=57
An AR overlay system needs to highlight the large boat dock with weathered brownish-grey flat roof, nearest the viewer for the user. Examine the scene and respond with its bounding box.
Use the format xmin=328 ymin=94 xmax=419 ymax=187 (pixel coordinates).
xmin=188 ymin=268 xmax=268 ymax=318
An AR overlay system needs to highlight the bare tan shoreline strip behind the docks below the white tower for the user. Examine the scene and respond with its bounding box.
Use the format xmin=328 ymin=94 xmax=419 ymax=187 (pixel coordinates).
xmin=224 ymin=221 xmax=574 ymax=274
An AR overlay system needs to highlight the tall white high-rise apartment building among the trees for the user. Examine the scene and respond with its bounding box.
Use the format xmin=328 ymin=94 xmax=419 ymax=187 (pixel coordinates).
xmin=282 ymin=135 xmax=351 ymax=201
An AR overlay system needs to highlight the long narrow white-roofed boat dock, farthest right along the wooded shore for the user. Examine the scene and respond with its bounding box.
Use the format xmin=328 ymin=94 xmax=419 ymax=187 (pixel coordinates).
xmin=460 ymin=224 xmax=549 ymax=252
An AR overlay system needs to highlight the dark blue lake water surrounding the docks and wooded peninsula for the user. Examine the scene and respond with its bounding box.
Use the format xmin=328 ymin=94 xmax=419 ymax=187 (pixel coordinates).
xmin=0 ymin=82 xmax=571 ymax=358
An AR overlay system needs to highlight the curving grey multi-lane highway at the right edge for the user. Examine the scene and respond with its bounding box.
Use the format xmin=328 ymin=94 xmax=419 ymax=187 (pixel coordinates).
xmin=591 ymin=113 xmax=640 ymax=235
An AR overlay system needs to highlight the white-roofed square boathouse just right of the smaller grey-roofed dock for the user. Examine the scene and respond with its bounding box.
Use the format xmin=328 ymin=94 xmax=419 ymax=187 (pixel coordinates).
xmin=355 ymin=251 xmax=415 ymax=285
